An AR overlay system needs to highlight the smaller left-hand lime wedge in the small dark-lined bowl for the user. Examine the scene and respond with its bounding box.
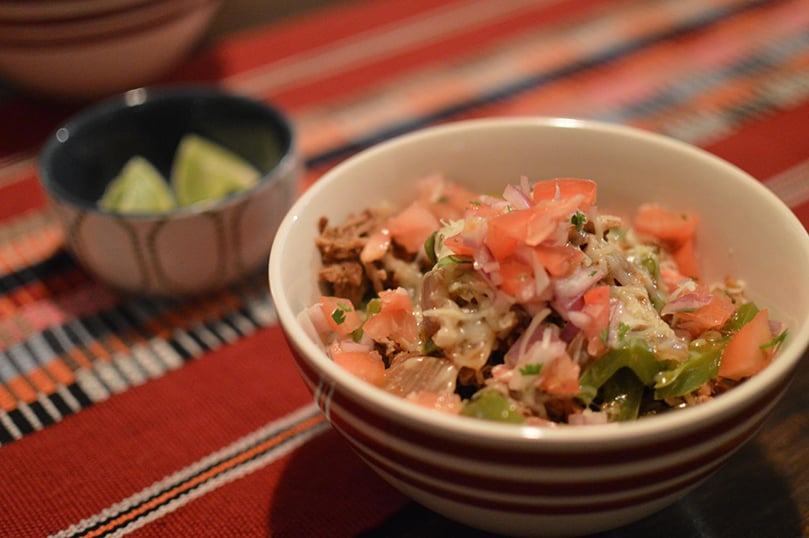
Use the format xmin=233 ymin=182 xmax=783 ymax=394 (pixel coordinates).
xmin=98 ymin=156 xmax=177 ymax=213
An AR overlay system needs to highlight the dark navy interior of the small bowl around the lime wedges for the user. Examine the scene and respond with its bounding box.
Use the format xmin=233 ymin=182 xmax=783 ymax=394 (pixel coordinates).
xmin=40 ymin=88 xmax=293 ymax=209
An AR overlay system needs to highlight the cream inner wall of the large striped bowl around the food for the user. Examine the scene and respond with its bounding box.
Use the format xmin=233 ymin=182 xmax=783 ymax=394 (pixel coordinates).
xmin=270 ymin=118 xmax=809 ymax=436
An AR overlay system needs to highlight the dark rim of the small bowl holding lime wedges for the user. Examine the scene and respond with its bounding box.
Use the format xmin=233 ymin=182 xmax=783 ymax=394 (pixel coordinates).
xmin=37 ymin=84 xmax=298 ymax=221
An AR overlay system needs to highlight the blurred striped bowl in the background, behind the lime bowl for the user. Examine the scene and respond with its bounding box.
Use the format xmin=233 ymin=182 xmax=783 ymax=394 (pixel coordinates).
xmin=0 ymin=0 xmax=221 ymax=100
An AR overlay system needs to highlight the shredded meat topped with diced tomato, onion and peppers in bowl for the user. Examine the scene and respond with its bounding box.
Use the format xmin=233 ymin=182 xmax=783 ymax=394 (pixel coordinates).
xmin=302 ymin=174 xmax=787 ymax=426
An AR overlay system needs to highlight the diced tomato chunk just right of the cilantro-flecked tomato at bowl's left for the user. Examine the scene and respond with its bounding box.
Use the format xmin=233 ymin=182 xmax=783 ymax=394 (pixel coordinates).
xmin=362 ymin=288 xmax=419 ymax=347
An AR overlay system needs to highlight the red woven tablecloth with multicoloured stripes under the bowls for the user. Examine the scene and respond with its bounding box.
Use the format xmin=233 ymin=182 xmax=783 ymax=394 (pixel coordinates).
xmin=0 ymin=0 xmax=809 ymax=536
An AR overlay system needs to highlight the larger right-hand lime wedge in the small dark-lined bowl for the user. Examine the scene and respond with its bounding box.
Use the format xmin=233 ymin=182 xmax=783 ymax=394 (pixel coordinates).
xmin=171 ymin=134 xmax=261 ymax=206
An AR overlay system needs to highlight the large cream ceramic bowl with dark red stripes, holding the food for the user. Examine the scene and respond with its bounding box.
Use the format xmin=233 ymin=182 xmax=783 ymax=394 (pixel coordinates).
xmin=269 ymin=118 xmax=809 ymax=535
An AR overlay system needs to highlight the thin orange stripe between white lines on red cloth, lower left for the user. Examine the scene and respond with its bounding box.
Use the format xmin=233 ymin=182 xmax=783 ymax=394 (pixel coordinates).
xmin=83 ymin=415 xmax=324 ymax=538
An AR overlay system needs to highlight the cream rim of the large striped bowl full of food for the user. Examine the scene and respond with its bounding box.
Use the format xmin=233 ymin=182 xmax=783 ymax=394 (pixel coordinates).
xmin=268 ymin=116 xmax=809 ymax=447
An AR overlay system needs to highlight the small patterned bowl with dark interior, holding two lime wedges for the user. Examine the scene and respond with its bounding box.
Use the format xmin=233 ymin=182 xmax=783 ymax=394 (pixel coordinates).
xmin=39 ymin=87 xmax=300 ymax=295
